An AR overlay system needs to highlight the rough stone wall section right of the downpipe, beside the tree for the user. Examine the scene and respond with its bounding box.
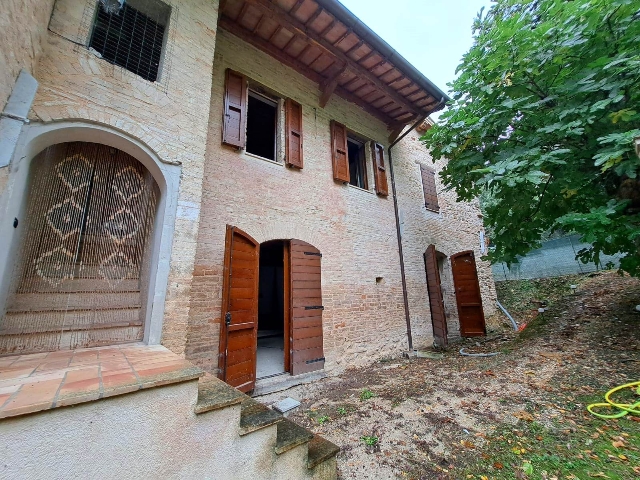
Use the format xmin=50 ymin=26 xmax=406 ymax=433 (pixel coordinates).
xmin=392 ymin=131 xmax=496 ymax=349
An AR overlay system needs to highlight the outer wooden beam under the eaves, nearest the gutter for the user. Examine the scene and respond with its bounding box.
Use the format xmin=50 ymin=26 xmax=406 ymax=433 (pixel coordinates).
xmin=242 ymin=0 xmax=424 ymax=114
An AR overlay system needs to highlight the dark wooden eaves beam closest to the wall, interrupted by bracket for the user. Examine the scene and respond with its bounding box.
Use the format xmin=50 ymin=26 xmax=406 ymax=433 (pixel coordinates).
xmin=218 ymin=15 xmax=394 ymax=125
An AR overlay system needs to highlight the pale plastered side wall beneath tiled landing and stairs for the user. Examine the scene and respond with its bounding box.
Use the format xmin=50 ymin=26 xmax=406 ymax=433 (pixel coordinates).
xmin=0 ymin=381 xmax=335 ymax=480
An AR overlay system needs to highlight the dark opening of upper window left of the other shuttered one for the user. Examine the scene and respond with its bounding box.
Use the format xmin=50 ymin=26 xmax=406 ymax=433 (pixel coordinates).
xmin=247 ymin=91 xmax=278 ymax=160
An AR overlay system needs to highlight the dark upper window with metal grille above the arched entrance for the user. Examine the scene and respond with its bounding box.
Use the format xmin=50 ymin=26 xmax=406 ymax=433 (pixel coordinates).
xmin=89 ymin=0 xmax=171 ymax=82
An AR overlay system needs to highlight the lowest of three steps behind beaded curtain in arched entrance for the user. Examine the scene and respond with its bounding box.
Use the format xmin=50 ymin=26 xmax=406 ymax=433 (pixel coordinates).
xmin=0 ymin=325 xmax=144 ymax=355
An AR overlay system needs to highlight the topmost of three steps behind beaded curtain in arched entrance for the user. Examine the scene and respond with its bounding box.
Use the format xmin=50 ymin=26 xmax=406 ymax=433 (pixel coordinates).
xmin=7 ymin=292 xmax=140 ymax=313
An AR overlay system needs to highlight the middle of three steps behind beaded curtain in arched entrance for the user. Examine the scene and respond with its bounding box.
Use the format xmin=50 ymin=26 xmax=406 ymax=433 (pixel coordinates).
xmin=0 ymin=308 xmax=142 ymax=335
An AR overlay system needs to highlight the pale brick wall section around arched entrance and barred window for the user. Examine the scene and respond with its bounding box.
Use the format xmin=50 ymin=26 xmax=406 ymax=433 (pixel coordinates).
xmin=20 ymin=0 xmax=218 ymax=353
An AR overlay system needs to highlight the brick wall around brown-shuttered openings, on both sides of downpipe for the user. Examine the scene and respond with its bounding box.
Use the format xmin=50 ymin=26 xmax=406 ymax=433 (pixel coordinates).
xmin=186 ymin=31 xmax=494 ymax=372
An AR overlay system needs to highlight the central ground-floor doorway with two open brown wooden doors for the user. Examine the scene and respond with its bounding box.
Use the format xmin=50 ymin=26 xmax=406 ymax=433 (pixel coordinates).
xmin=218 ymin=225 xmax=325 ymax=392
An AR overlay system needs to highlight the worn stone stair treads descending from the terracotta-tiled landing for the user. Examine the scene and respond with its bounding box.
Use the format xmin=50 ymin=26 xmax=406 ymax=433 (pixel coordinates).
xmin=195 ymin=377 xmax=340 ymax=480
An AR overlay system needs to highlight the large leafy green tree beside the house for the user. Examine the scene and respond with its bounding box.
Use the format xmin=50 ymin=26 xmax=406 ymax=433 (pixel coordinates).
xmin=423 ymin=0 xmax=640 ymax=276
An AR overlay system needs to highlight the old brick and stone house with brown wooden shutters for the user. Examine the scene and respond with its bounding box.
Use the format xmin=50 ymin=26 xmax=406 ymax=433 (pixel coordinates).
xmin=0 ymin=0 xmax=495 ymax=405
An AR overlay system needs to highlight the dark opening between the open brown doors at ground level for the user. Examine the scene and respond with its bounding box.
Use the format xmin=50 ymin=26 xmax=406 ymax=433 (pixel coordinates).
xmin=256 ymin=240 xmax=289 ymax=378
